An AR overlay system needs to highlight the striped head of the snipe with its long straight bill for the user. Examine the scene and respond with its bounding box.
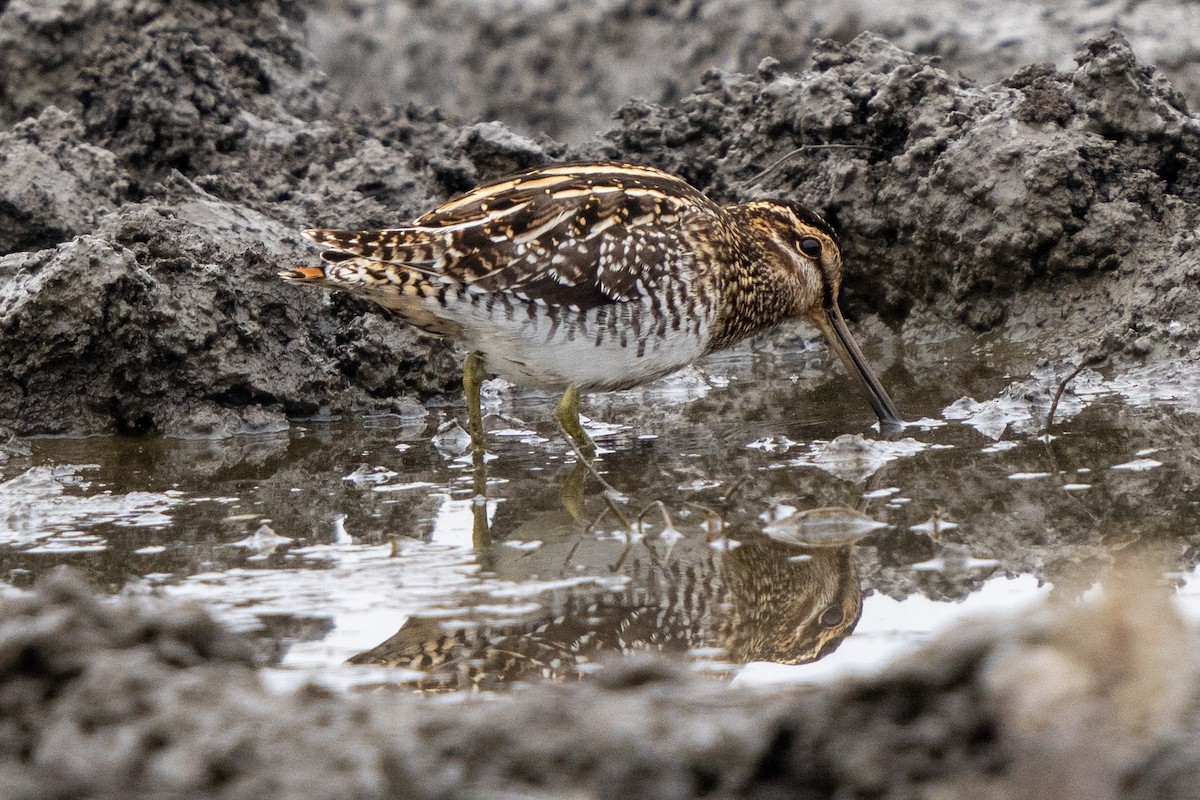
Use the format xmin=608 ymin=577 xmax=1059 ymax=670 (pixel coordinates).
xmin=744 ymin=200 xmax=902 ymax=428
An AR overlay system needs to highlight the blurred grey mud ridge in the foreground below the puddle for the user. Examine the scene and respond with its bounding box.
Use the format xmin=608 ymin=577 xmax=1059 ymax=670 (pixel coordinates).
xmin=0 ymin=573 xmax=1196 ymax=799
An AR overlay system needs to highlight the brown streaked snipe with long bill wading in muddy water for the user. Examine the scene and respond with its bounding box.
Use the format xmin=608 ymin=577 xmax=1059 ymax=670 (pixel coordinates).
xmin=280 ymin=162 xmax=902 ymax=453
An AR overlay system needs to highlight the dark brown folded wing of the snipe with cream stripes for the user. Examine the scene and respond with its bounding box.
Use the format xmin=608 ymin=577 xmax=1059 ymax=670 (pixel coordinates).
xmin=305 ymin=163 xmax=720 ymax=308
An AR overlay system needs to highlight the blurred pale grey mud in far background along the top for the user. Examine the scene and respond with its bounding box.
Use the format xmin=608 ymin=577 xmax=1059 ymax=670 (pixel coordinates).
xmin=306 ymin=0 xmax=1200 ymax=142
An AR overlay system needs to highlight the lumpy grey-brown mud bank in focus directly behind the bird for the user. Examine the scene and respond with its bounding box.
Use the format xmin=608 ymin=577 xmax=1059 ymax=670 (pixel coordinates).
xmin=0 ymin=1 xmax=1200 ymax=437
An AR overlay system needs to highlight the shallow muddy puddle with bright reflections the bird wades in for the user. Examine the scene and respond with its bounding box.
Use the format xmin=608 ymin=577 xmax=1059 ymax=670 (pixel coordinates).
xmin=0 ymin=339 xmax=1200 ymax=690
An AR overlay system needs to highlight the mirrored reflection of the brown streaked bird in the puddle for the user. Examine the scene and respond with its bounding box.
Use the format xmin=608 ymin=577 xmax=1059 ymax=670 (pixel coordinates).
xmin=350 ymin=534 xmax=863 ymax=691
